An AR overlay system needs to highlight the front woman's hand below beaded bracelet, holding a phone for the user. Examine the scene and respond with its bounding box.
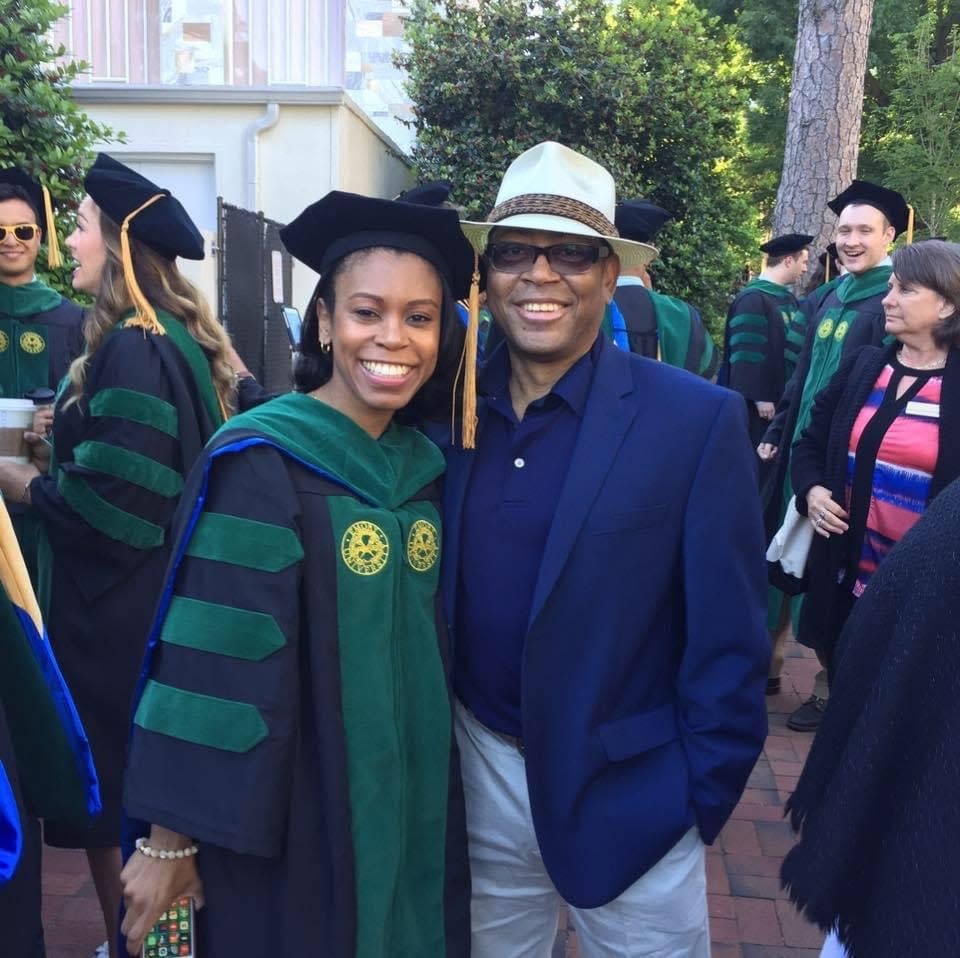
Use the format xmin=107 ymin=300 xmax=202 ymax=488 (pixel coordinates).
xmin=120 ymin=825 xmax=203 ymax=955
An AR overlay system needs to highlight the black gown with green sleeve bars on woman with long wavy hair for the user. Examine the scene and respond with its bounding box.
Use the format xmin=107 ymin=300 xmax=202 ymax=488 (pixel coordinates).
xmin=30 ymin=314 xmax=219 ymax=848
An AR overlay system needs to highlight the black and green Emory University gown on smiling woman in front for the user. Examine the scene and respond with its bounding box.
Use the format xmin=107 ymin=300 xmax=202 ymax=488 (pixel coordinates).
xmin=124 ymin=394 xmax=470 ymax=958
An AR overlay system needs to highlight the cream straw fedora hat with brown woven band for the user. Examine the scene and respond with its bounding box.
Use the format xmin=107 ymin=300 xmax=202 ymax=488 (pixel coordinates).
xmin=460 ymin=141 xmax=657 ymax=269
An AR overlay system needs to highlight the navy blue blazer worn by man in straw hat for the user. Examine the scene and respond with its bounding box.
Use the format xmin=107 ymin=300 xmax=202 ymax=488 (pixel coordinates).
xmin=443 ymin=343 xmax=770 ymax=908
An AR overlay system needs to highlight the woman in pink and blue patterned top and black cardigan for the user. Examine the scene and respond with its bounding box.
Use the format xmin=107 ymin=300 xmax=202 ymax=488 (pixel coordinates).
xmin=791 ymin=240 xmax=960 ymax=662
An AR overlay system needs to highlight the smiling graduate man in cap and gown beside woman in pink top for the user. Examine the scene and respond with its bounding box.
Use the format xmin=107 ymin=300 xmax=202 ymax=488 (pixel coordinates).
xmin=757 ymin=180 xmax=913 ymax=732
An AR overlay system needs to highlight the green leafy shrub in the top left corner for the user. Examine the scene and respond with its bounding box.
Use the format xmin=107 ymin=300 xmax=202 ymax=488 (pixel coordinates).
xmin=0 ymin=0 xmax=122 ymax=294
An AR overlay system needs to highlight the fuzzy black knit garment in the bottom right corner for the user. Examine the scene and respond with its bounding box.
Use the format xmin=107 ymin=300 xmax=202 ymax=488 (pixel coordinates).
xmin=781 ymin=482 xmax=960 ymax=958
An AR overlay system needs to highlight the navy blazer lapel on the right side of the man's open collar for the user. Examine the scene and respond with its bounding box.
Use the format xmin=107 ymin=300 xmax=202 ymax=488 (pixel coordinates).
xmin=528 ymin=342 xmax=637 ymax=627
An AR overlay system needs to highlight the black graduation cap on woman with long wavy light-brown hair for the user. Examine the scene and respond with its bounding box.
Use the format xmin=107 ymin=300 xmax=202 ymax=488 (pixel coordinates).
xmin=83 ymin=153 xmax=203 ymax=260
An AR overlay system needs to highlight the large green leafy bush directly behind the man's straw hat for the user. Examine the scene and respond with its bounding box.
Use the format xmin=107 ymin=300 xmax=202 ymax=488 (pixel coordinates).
xmin=401 ymin=0 xmax=761 ymax=333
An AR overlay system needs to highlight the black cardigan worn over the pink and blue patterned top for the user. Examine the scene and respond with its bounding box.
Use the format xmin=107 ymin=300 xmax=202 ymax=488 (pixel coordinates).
xmin=790 ymin=343 xmax=960 ymax=658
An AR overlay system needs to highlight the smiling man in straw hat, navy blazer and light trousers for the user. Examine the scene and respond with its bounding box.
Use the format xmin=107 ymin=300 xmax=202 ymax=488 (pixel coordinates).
xmin=444 ymin=143 xmax=768 ymax=958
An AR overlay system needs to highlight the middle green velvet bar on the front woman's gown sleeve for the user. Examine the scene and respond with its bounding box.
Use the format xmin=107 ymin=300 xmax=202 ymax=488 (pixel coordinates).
xmin=160 ymin=595 xmax=287 ymax=662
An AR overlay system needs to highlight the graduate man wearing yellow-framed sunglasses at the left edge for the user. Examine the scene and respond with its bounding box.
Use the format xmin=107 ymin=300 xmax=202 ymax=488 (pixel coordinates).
xmin=0 ymin=167 xmax=83 ymax=582
